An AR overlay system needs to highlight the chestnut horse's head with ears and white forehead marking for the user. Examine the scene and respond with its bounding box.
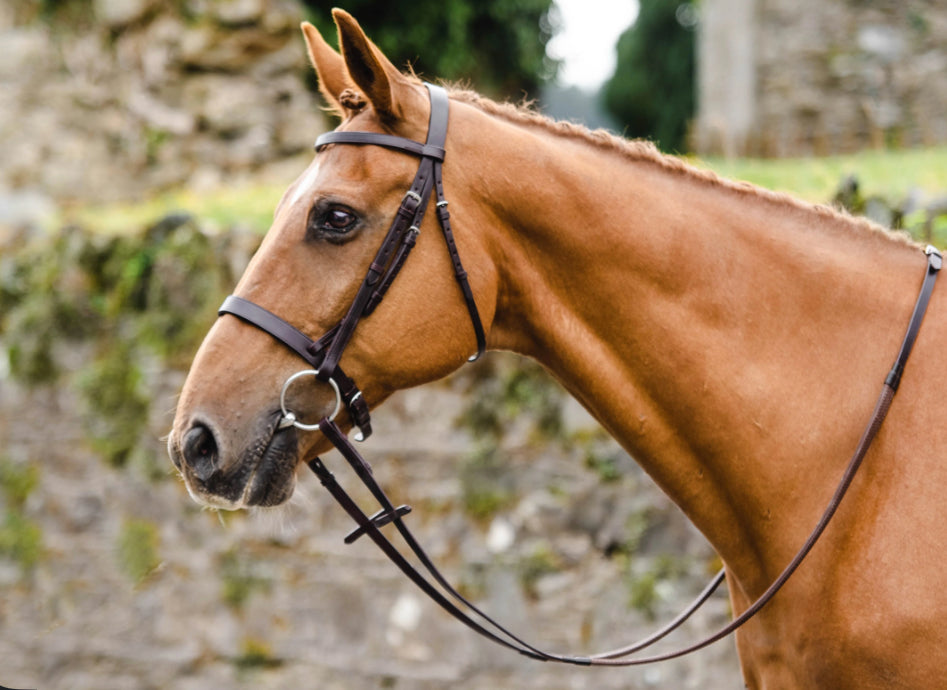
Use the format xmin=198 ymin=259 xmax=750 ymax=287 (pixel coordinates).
xmin=168 ymin=10 xmax=496 ymax=509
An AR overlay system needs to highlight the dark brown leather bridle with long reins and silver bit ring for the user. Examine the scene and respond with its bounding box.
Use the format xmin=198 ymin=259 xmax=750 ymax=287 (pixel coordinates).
xmin=219 ymin=84 xmax=943 ymax=666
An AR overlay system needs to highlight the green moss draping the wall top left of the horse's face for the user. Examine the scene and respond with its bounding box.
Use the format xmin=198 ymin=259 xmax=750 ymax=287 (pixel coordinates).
xmin=0 ymin=214 xmax=244 ymax=475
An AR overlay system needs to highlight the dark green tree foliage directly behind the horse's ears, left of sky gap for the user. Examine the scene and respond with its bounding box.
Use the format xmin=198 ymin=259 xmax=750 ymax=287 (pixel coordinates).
xmin=304 ymin=0 xmax=558 ymax=98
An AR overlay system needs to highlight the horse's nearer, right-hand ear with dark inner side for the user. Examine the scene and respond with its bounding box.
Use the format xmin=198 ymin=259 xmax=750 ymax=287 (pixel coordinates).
xmin=332 ymin=9 xmax=404 ymax=122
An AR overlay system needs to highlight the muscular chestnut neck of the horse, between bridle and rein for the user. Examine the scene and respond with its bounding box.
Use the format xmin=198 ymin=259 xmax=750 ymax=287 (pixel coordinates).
xmin=460 ymin=110 xmax=922 ymax=589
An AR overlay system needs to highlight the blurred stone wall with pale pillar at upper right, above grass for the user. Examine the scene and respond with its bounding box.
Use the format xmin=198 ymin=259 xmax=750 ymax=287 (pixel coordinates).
xmin=695 ymin=0 xmax=947 ymax=156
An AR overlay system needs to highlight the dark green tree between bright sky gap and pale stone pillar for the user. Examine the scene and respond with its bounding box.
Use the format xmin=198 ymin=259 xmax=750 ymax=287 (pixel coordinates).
xmin=603 ymin=0 xmax=697 ymax=151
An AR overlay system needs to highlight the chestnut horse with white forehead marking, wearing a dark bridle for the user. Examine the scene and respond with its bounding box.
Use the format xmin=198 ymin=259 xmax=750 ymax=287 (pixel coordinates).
xmin=169 ymin=11 xmax=947 ymax=689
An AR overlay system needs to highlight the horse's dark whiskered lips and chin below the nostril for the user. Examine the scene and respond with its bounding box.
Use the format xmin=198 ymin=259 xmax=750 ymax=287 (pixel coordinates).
xmin=180 ymin=428 xmax=298 ymax=510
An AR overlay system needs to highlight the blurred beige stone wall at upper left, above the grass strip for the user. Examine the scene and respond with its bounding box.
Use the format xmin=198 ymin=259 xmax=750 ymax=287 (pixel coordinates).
xmin=0 ymin=0 xmax=325 ymax=207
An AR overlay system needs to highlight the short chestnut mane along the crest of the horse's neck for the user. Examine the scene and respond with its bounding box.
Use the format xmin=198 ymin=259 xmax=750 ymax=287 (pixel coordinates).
xmin=449 ymin=86 xmax=920 ymax=247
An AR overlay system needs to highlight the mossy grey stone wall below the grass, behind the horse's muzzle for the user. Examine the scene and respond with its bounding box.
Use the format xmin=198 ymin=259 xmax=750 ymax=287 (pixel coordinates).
xmin=0 ymin=215 xmax=740 ymax=690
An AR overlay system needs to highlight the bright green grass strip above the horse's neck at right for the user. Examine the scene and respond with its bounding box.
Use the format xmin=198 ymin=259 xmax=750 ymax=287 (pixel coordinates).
xmin=690 ymin=147 xmax=947 ymax=203
